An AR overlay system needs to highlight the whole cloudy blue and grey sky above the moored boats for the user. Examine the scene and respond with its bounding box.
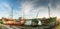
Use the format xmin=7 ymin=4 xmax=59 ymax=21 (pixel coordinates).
xmin=0 ymin=0 xmax=60 ymax=19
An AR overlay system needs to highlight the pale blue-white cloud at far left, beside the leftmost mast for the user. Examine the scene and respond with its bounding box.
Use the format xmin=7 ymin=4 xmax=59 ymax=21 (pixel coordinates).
xmin=0 ymin=3 xmax=11 ymax=18
